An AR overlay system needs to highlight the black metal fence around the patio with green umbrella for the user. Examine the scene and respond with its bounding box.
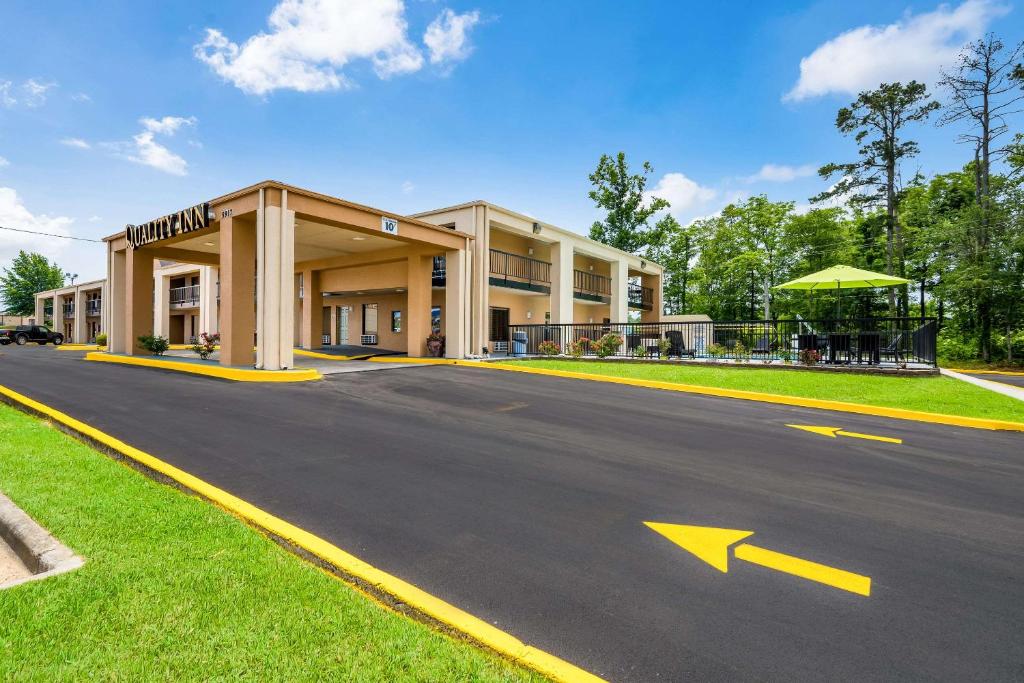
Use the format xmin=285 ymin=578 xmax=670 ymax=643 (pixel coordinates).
xmin=509 ymin=317 xmax=937 ymax=367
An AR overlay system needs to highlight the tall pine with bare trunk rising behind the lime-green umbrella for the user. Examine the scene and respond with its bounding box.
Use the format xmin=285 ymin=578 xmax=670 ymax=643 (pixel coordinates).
xmin=812 ymin=81 xmax=939 ymax=315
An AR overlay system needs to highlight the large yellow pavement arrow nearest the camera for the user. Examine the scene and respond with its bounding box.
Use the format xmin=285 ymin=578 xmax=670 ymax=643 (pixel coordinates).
xmin=644 ymin=522 xmax=871 ymax=596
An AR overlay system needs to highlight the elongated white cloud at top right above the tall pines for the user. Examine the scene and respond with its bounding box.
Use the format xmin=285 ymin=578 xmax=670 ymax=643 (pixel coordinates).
xmin=783 ymin=0 xmax=1010 ymax=101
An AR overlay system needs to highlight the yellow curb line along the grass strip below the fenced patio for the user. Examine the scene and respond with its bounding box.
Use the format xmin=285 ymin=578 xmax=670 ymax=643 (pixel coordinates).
xmin=471 ymin=362 xmax=1024 ymax=431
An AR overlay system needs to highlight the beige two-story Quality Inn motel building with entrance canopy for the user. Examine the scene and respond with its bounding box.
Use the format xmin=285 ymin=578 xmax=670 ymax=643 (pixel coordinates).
xmin=36 ymin=181 xmax=662 ymax=370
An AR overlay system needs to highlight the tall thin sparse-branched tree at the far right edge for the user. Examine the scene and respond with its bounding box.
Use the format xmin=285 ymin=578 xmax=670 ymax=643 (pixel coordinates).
xmin=939 ymin=34 xmax=1024 ymax=362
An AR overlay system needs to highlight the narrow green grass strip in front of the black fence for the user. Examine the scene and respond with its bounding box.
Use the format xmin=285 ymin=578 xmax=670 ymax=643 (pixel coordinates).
xmin=516 ymin=360 xmax=1024 ymax=422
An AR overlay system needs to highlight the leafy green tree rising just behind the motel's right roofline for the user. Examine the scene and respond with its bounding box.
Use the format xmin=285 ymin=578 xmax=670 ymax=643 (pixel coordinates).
xmin=590 ymin=152 xmax=669 ymax=254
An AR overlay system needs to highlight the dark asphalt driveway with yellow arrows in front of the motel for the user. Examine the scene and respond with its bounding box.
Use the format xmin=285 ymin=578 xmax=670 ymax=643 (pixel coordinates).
xmin=0 ymin=347 xmax=1024 ymax=681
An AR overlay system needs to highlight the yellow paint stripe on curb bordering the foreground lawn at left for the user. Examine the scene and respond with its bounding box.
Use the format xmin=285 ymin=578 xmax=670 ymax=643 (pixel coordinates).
xmin=0 ymin=385 xmax=603 ymax=683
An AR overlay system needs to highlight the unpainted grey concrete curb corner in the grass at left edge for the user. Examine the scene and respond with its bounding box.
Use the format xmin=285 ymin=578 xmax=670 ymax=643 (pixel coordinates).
xmin=0 ymin=494 xmax=84 ymax=589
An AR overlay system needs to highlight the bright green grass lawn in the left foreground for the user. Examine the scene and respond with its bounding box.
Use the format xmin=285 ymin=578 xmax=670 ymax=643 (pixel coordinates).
xmin=0 ymin=404 xmax=542 ymax=682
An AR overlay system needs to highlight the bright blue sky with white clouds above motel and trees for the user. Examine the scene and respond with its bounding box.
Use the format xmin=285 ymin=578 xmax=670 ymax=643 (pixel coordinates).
xmin=0 ymin=0 xmax=1024 ymax=279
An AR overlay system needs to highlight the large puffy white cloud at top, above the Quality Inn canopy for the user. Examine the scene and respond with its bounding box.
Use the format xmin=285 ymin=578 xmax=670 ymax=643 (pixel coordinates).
xmin=194 ymin=0 xmax=432 ymax=95
